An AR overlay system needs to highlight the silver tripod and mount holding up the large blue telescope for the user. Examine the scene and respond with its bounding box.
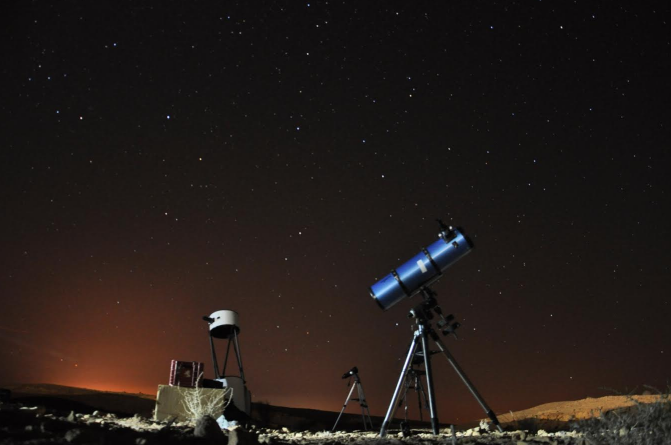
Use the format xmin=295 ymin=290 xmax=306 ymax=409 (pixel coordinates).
xmin=380 ymin=287 xmax=503 ymax=437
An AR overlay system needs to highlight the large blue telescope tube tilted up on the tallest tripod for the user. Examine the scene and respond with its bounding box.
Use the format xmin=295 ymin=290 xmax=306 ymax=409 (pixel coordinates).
xmin=369 ymin=224 xmax=472 ymax=311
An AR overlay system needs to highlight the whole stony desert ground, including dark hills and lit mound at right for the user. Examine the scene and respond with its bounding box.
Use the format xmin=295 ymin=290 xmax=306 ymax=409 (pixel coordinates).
xmin=0 ymin=385 xmax=671 ymax=445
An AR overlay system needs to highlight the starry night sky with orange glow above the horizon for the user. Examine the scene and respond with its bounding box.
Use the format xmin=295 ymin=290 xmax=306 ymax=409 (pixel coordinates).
xmin=0 ymin=0 xmax=671 ymax=422
